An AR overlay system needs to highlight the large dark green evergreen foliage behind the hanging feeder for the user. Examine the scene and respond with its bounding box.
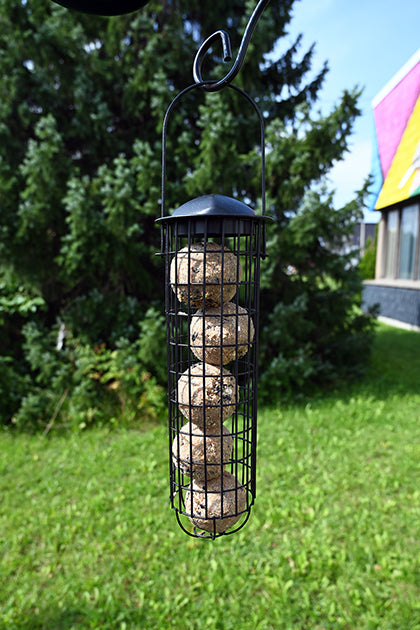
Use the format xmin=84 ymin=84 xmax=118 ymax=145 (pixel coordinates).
xmin=0 ymin=0 xmax=370 ymax=427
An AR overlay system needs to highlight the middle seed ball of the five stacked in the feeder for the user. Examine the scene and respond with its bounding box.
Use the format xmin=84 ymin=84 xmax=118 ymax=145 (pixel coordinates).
xmin=178 ymin=363 xmax=239 ymax=428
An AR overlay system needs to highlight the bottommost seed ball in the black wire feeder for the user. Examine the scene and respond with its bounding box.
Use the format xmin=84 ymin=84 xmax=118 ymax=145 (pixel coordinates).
xmin=185 ymin=470 xmax=246 ymax=533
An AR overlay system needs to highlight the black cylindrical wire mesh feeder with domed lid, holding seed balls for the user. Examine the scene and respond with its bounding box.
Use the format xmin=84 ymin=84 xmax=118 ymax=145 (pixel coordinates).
xmin=158 ymin=88 xmax=266 ymax=538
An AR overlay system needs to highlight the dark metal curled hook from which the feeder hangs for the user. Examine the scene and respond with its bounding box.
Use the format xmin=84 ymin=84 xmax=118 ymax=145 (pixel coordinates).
xmin=193 ymin=0 xmax=270 ymax=92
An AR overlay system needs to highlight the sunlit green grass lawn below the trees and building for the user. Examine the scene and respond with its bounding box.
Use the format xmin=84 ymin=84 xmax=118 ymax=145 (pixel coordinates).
xmin=0 ymin=326 xmax=420 ymax=630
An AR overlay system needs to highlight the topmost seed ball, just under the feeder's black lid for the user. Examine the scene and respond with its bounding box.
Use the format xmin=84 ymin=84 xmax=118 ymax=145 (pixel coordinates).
xmin=170 ymin=243 xmax=241 ymax=307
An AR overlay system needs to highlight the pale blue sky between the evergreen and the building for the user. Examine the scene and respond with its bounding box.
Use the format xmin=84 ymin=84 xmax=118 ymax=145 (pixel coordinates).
xmin=280 ymin=0 xmax=420 ymax=221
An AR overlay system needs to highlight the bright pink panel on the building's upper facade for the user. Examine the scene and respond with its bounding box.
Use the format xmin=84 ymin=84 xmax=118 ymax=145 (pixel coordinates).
xmin=373 ymin=63 xmax=420 ymax=179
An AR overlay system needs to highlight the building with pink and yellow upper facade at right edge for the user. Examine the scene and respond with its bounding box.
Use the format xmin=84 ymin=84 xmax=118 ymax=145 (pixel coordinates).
xmin=363 ymin=49 xmax=420 ymax=331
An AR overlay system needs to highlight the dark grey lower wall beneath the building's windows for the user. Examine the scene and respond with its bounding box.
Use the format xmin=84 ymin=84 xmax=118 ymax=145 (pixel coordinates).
xmin=363 ymin=284 xmax=420 ymax=326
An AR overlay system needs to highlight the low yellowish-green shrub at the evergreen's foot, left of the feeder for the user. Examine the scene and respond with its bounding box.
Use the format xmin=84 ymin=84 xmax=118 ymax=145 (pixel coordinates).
xmin=12 ymin=323 xmax=165 ymax=431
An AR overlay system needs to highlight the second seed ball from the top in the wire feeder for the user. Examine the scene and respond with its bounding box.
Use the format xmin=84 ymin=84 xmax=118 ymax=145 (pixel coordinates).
xmin=190 ymin=302 xmax=255 ymax=365
